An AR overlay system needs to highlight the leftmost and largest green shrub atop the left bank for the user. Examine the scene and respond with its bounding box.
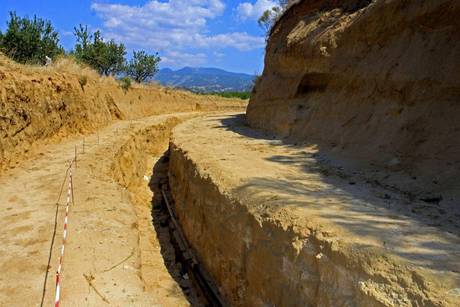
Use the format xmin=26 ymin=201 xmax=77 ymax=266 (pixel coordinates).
xmin=0 ymin=12 xmax=64 ymax=64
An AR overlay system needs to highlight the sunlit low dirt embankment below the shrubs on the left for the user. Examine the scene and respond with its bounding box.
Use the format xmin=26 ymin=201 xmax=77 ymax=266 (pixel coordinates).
xmin=0 ymin=55 xmax=245 ymax=170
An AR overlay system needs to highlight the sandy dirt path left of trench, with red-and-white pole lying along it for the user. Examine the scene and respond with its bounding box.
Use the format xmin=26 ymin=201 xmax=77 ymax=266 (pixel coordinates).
xmin=0 ymin=114 xmax=199 ymax=306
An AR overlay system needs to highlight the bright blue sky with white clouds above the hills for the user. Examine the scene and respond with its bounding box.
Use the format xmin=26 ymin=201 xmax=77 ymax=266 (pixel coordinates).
xmin=0 ymin=0 xmax=276 ymax=74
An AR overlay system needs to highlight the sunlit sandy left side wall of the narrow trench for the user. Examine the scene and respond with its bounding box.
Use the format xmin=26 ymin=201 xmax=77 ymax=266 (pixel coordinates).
xmin=110 ymin=113 xmax=197 ymax=306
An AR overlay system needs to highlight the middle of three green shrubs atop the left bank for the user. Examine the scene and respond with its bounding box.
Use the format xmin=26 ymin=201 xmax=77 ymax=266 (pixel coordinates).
xmin=73 ymin=25 xmax=126 ymax=76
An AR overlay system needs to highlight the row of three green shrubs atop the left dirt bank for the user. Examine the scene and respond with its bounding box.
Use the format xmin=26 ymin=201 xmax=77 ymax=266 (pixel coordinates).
xmin=0 ymin=12 xmax=161 ymax=83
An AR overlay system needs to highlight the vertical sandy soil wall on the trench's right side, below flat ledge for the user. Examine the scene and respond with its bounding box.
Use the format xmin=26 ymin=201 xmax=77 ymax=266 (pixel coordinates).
xmin=169 ymin=137 xmax=453 ymax=306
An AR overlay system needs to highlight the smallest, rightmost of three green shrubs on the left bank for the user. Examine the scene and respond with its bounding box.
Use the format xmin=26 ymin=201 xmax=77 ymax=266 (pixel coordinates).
xmin=126 ymin=51 xmax=161 ymax=83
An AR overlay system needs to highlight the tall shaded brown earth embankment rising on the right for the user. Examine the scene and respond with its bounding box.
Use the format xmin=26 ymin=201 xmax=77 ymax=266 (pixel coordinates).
xmin=247 ymin=0 xmax=460 ymax=205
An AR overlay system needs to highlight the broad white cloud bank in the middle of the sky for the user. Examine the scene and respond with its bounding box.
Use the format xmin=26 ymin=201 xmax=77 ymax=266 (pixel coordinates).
xmin=91 ymin=0 xmax=265 ymax=65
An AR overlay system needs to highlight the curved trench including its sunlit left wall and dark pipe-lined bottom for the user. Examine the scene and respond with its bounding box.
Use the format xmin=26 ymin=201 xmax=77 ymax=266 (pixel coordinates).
xmin=111 ymin=115 xmax=224 ymax=306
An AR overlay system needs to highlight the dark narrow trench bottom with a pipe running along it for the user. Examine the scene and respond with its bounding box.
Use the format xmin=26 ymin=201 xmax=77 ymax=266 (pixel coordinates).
xmin=149 ymin=150 xmax=226 ymax=306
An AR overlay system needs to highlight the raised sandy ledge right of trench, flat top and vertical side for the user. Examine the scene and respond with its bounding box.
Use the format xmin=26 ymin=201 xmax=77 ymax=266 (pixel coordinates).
xmin=169 ymin=115 xmax=460 ymax=306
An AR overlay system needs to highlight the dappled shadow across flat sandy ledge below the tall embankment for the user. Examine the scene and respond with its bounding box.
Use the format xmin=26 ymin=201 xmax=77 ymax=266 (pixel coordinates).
xmin=216 ymin=114 xmax=460 ymax=272
